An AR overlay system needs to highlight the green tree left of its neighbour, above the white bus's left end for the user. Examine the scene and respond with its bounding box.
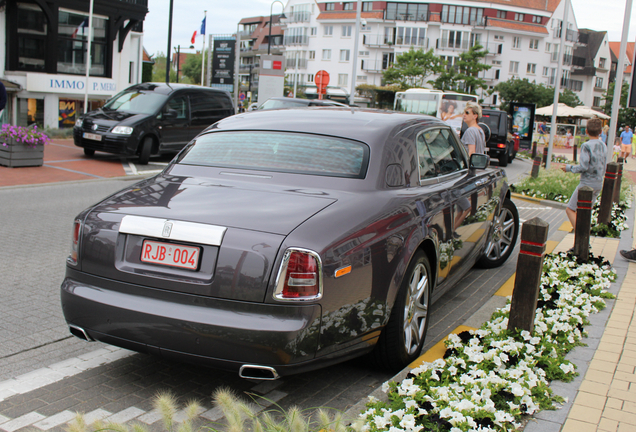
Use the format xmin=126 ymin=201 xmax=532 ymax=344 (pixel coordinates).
xmin=383 ymin=47 xmax=442 ymax=90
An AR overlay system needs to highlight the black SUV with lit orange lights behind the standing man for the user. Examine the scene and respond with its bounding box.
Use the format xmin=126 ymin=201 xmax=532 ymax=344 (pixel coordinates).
xmin=480 ymin=109 xmax=519 ymax=167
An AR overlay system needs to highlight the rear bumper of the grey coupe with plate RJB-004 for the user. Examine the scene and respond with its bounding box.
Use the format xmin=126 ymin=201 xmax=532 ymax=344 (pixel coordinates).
xmin=61 ymin=268 xmax=321 ymax=370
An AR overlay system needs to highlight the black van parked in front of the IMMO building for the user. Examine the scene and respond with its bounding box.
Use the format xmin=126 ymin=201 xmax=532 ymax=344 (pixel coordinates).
xmin=73 ymin=83 xmax=234 ymax=164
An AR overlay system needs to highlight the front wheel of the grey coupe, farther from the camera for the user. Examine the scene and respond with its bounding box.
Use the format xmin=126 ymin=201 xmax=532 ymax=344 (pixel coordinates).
xmin=477 ymin=199 xmax=519 ymax=268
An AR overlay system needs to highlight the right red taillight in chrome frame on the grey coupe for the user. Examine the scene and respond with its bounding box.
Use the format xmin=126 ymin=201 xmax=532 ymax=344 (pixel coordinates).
xmin=274 ymin=248 xmax=322 ymax=301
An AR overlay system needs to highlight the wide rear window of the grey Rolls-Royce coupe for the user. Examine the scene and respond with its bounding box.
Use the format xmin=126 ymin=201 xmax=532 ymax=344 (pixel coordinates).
xmin=179 ymin=131 xmax=369 ymax=178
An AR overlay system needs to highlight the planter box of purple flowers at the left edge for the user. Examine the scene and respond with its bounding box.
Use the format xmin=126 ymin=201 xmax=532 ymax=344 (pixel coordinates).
xmin=0 ymin=124 xmax=49 ymax=167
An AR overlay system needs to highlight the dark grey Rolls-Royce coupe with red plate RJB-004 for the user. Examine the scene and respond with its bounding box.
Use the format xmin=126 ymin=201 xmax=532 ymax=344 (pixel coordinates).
xmin=61 ymin=108 xmax=519 ymax=379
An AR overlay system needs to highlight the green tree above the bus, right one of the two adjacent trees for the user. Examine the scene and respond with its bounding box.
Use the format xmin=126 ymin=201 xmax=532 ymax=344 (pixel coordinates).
xmin=433 ymin=44 xmax=492 ymax=94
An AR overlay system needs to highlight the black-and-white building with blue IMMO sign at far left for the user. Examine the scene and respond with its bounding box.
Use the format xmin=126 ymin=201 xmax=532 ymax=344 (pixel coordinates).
xmin=0 ymin=0 xmax=148 ymax=128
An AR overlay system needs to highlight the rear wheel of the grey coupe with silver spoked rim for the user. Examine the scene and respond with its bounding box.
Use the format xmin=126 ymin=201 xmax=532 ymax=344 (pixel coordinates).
xmin=372 ymin=251 xmax=433 ymax=370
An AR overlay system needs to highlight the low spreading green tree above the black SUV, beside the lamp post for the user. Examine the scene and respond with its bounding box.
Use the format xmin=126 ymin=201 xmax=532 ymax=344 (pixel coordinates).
xmin=492 ymin=78 xmax=581 ymax=111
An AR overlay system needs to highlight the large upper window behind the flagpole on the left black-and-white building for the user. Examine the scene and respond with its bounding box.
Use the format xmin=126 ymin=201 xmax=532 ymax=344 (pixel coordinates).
xmin=57 ymin=9 xmax=108 ymax=76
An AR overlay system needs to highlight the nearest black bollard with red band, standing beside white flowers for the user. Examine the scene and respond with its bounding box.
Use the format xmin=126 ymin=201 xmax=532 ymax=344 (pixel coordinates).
xmin=508 ymin=218 xmax=550 ymax=333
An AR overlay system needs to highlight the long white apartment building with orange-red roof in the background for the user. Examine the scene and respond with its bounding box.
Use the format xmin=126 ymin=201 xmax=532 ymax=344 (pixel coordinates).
xmin=247 ymin=0 xmax=610 ymax=106
